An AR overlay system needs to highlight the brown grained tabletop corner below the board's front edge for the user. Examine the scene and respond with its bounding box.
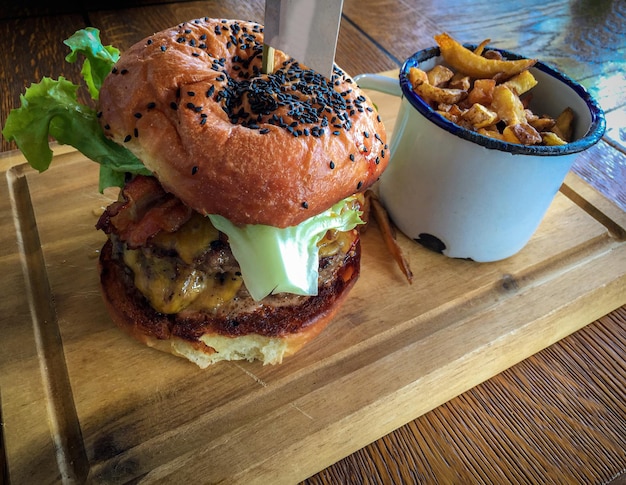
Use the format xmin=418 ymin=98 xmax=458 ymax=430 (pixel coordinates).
xmin=303 ymin=307 xmax=626 ymax=485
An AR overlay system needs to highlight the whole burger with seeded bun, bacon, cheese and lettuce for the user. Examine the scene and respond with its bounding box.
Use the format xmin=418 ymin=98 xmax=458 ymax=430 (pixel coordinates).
xmin=3 ymin=18 xmax=388 ymax=368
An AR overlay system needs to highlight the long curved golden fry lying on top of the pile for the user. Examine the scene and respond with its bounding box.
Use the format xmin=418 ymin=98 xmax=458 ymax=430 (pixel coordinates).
xmin=435 ymin=33 xmax=537 ymax=78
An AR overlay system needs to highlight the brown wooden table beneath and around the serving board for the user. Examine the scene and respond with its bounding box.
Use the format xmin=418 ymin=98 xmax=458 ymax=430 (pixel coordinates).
xmin=0 ymin=0 xmax=626 ymax=484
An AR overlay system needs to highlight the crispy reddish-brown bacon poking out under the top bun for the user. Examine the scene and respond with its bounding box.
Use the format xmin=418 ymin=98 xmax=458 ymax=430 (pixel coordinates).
xmin=96 ymin=175 xmax=192 ymax=249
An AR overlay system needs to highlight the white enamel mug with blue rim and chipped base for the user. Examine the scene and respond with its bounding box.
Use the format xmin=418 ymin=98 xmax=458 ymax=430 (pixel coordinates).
xmin=355 ymin=46 xmax=605 ymax=262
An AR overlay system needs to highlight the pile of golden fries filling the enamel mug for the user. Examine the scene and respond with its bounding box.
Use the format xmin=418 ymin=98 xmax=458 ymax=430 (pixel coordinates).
xmin=409 ymin=33 xmax=574 ymax=146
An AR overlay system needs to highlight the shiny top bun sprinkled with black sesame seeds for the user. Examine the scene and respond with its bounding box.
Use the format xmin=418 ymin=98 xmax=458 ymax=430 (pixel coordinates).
xmin=100 ymin=18 xmax=389 ymax=227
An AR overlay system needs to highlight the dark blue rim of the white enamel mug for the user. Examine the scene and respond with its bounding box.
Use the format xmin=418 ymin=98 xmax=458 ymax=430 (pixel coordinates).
xmin=399 ymin=44 xmax=606 ymax=156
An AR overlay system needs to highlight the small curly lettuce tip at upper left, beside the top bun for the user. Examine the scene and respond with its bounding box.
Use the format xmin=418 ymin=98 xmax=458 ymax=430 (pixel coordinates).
xmin=63 ymin=27 xmax=120 ymax=100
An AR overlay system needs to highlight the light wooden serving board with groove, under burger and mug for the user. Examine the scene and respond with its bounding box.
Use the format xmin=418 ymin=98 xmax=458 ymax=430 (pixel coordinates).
xmin=0 ymin=87 xmax=626 ymax=484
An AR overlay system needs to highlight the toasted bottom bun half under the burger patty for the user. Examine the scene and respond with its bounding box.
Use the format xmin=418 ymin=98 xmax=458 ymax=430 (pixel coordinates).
xmin=99 ymin=239 xmax=361 ymax=369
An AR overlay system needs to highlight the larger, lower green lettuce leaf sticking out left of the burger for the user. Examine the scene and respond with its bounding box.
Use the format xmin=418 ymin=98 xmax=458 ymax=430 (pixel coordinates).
xmin=2 ymin=77 xmax=151 ymax=191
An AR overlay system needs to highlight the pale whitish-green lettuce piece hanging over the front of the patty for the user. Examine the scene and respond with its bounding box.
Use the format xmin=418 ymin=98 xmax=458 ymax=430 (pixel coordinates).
xmin=208 ymin=197 xmax=363 ymax=301
